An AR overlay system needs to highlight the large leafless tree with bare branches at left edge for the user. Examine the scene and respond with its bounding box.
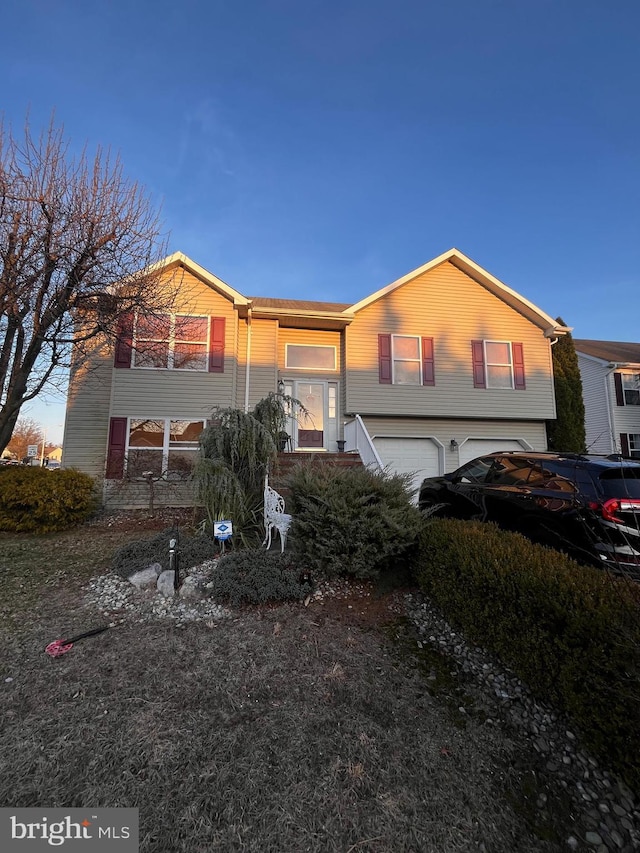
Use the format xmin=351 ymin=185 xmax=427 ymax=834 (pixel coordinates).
xmin=0 ymin=120 xmax=174 ymax=460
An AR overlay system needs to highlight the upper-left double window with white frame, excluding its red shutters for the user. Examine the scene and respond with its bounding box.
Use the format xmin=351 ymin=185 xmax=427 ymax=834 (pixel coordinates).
xmin=133 ymin=314 xmax=209 ymax=371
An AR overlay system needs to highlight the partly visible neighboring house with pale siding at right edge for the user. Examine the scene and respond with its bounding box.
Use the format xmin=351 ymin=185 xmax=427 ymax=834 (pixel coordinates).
xmin=573 ymin=339 xmax=640 ymax=457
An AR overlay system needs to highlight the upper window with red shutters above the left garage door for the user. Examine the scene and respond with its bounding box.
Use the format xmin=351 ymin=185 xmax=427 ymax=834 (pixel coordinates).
xmin=378 ymin=335 xmax=436 ymax=385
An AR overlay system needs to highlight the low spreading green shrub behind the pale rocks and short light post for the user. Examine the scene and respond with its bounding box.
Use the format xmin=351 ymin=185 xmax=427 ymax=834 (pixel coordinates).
xmin=113 ymin=527 xmax=218 ymax=577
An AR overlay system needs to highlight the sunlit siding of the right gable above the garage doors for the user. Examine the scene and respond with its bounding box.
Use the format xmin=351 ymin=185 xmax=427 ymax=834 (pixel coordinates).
xmin=346 ymin=262 xmax=555 ymax=420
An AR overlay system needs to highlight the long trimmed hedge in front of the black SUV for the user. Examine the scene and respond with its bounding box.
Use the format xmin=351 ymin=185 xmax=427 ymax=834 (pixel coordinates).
xmin=416 ymin=520 xmax=640 ymax=789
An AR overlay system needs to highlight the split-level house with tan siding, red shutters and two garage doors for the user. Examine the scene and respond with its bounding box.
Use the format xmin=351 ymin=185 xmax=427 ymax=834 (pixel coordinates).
xmin=63 ymin=249 xmax=568 ymax=506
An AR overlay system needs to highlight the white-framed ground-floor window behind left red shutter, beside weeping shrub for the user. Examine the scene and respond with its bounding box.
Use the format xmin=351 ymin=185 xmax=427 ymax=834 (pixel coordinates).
xmin=126 ymin=418 xmax=206 ymax=480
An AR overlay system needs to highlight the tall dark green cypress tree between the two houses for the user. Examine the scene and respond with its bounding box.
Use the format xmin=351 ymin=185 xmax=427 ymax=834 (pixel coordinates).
xmin=547 ymin=317 xmax=587 ymax=453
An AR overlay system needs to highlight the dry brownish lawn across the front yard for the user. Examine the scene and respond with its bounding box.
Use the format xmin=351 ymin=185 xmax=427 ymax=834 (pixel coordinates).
xmin=0 ymin=521 xmax=571 ymax=853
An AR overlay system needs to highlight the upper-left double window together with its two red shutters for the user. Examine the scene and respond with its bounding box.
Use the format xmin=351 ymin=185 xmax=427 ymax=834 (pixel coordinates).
xmin=114 ymin=314 xmax=225 ymax=373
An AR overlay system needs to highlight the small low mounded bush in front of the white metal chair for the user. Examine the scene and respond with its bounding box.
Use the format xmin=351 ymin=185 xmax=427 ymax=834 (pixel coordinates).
xmin=211 ymin=550 xmax=311 ymax=607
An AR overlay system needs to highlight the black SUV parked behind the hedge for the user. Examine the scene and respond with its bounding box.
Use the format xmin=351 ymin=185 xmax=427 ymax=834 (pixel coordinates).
xmin=419 ymin=451 xmax=640 ymax=578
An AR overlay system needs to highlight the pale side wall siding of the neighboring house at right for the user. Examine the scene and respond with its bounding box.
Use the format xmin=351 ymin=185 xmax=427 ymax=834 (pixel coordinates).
xmin=577 ymin=353 xmax=620 ymax=454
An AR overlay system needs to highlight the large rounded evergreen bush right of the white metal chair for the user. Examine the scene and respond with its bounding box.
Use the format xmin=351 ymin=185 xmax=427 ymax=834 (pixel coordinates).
xmin=287 ymin=465 xmax=422 ymax=578
